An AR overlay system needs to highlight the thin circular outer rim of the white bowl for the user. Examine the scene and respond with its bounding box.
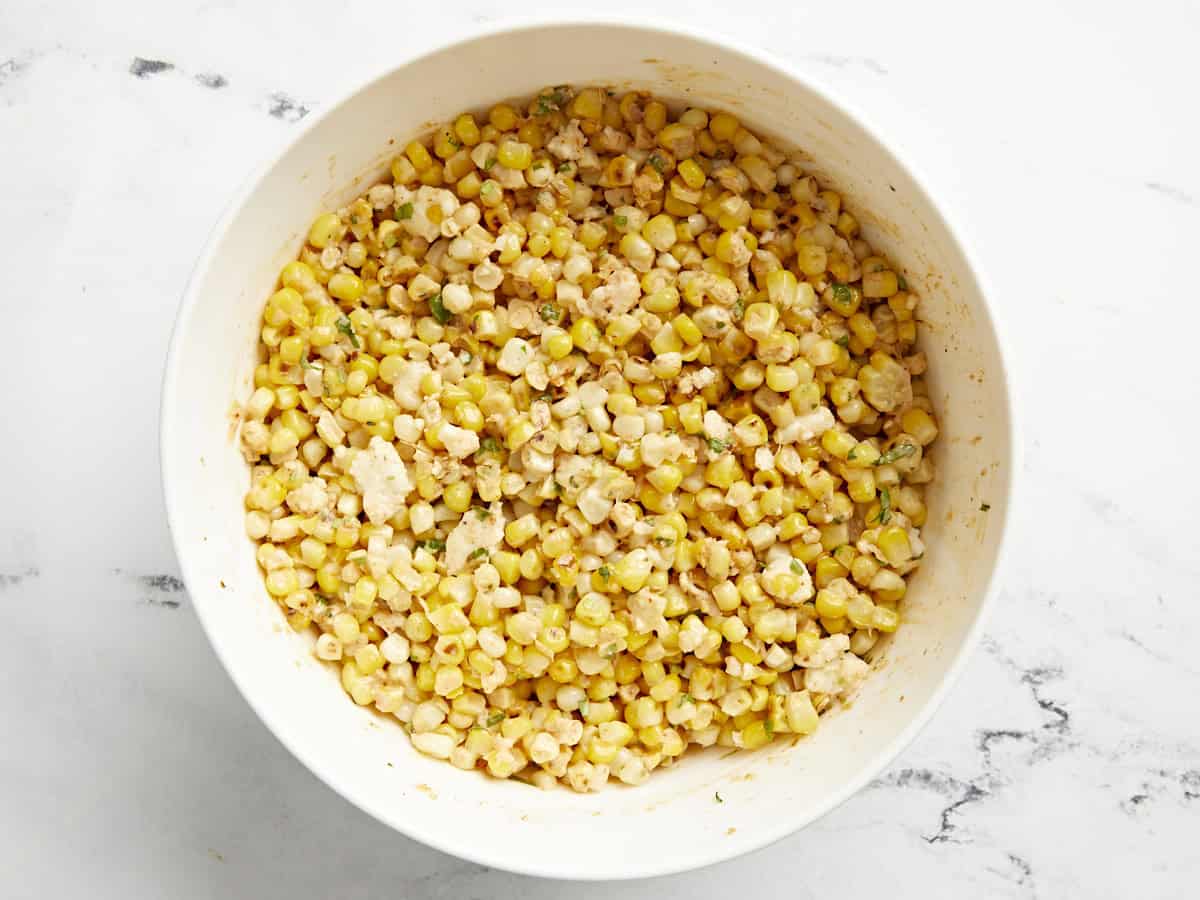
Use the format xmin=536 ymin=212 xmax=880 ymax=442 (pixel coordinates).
xmin=158 ymin=13 xmax=1022 ymax=881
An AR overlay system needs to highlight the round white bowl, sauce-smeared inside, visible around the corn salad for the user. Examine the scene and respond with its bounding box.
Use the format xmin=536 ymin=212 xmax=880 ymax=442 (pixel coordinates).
xmin=162 ymin=22 xmax=1015 ymax=878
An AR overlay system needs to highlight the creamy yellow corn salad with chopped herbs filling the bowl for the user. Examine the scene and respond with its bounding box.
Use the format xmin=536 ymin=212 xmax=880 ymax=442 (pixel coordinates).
xmin=240 ymin=86 xmax=937 ymax=791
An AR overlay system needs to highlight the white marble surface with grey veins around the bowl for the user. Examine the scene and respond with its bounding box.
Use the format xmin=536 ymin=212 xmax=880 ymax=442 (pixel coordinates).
xmin=0 ymin=0 xmax=1200 ymax=900
